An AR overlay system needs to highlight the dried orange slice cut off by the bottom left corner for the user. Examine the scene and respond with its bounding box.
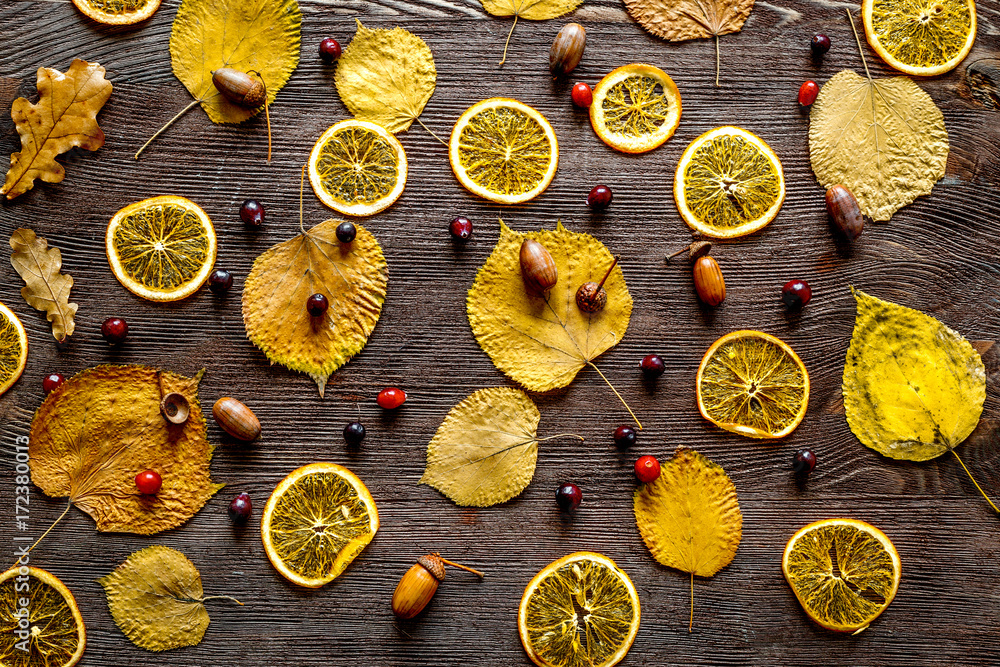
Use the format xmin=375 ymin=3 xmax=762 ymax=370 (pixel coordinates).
xmin=0 ymin=567 xmax=87 ymax=667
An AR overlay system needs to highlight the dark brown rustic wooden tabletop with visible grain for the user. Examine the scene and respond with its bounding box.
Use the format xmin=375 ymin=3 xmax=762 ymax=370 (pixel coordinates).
xmin=0 ymin=0 xmax=1000 ymax=667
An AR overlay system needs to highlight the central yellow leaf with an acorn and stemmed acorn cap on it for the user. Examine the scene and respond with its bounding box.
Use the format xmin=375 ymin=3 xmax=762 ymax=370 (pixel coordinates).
xmin=466 ymin=220 xmax=632 ymax=391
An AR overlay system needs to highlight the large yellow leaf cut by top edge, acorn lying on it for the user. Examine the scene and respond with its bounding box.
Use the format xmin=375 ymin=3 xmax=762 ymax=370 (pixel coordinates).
xmin=170 ymin=0 xmax=302 ymax=123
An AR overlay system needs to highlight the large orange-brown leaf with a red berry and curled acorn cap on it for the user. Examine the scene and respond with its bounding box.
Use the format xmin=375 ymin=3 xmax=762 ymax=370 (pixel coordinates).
xmin=28 ymin=365 xmax=223 ymax=535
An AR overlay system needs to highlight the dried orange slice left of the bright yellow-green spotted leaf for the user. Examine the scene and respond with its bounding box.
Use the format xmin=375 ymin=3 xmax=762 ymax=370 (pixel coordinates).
xmin=696 ymin=331 xmax=809 ymax=438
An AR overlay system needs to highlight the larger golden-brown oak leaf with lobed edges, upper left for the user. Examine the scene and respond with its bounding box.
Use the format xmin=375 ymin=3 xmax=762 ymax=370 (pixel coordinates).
xmin=0 ymin=59 xmax=111 ymax=199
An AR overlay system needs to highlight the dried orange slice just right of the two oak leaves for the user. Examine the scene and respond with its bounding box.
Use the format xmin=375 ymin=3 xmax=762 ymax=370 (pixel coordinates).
xmin=104 ymin=195 xmax=216 ymax=301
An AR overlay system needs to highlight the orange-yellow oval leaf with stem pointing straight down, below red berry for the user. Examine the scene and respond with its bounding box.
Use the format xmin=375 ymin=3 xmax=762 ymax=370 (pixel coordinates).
xmin=632 ymin=448 xmax=743 ymax=629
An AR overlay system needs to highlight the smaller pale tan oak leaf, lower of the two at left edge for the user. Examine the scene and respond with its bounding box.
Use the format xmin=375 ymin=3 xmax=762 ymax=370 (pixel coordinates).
xmin=10 ymin=229 xmax=79 ymax=343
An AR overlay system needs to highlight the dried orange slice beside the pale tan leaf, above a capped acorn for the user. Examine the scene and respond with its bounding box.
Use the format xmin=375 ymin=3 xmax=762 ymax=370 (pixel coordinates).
xmin=674 ymin=125 xmax=785 ymax=239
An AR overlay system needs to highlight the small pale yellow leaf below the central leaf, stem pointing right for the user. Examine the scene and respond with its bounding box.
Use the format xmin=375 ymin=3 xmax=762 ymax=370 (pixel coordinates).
xmin=420 ymin=387 xmax=542 ymax=507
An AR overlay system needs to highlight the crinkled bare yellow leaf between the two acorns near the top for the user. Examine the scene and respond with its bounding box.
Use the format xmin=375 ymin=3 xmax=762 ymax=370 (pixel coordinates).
xmin=336 ymin=19 xmax=437 ymax=133
